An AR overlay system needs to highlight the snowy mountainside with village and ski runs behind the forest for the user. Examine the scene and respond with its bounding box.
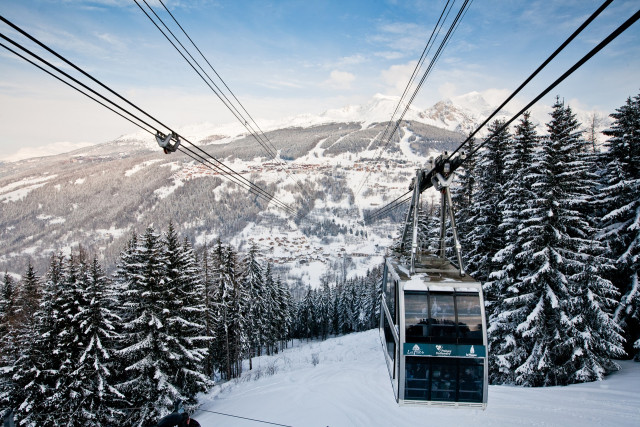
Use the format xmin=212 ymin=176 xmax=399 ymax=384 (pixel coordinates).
xmin=0 ymin=93 xmax=608 ymax=285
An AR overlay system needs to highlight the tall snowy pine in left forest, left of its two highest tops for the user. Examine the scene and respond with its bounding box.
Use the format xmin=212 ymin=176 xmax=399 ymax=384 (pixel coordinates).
xmin=115 ymin=227 xmax=176 ymax=426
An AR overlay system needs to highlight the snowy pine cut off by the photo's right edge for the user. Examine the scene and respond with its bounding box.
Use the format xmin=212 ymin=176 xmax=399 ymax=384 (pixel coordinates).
xmin=601 ymin=94 xmax=640 ymax=362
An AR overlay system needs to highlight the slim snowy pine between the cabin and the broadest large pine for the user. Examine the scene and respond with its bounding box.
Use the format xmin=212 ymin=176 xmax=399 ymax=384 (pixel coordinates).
xmin=487 ymin=112 xmax=538 ymax=384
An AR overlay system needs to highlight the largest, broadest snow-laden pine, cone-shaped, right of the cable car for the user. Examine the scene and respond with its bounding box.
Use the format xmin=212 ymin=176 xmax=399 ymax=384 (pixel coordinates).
xmin=513 ymin=100 xmax=620 ymax=386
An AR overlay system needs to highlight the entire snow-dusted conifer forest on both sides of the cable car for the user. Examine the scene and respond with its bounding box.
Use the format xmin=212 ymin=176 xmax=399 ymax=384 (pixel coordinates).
xmin=0 ymin=90 xmax=640 ymax=426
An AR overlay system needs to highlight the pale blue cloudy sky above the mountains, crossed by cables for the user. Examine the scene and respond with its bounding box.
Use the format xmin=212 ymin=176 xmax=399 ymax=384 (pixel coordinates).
xmin=0 ymin=0 xmax=640 ymax=160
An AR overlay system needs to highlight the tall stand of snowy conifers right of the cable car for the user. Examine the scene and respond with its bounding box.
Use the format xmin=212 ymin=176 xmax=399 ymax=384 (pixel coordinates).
xmin=455 ymin=95 xmax=640 ymax=386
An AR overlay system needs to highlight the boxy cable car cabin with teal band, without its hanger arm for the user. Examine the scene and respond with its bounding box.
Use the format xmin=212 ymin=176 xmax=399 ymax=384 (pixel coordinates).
xmin=380 ymin=254 xmax=488 ymax=409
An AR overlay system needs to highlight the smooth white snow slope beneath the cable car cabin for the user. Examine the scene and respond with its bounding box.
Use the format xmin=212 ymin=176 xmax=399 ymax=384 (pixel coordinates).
xmin=194 ymin=330 xmax=640 ymax=427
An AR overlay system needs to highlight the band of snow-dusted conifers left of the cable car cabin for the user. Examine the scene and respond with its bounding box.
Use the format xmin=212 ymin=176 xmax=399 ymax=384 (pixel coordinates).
xmin=0 ymin=224 xmax=375 ymax=426
